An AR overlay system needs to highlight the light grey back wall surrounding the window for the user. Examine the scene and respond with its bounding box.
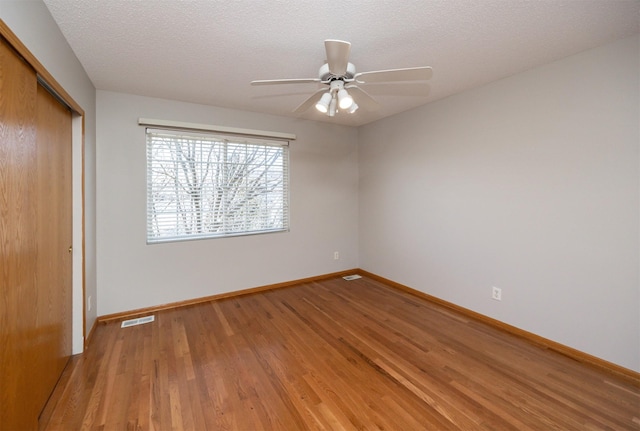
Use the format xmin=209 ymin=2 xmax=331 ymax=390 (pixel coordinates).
xmin=97 ymin=88 xmax=358 ymax=315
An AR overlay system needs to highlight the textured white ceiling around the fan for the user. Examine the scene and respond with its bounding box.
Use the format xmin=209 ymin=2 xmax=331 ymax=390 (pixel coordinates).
xmin=44 ymin=0 xmax=640 ymax=125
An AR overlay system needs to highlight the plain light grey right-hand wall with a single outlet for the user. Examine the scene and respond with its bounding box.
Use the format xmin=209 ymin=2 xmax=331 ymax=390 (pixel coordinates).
xmin=359 ymin=37 xmax=640 ymax=371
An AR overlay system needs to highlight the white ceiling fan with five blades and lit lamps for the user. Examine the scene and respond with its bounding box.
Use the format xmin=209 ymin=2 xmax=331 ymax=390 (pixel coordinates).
xmin=251 ymin=39 xmax=433 ymax=117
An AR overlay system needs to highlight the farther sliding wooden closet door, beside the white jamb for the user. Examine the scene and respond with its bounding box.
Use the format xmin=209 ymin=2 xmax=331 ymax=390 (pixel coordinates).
xmin=32 ymin=81 xmax=72 ymax=413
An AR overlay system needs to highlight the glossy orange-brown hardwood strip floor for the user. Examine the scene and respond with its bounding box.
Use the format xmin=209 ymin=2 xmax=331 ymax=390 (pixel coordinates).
xmin=45 ymin=278 xmax=640 ymax=431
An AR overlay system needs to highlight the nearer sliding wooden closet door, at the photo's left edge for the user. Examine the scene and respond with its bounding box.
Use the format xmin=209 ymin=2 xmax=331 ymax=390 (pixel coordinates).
xmin=0 ymin=37 xmax=38 ymax=430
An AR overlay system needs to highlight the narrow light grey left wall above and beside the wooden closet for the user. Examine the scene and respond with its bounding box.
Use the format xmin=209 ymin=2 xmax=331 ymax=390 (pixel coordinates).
xmin=0 ymin=0 xmax=96 ymax=353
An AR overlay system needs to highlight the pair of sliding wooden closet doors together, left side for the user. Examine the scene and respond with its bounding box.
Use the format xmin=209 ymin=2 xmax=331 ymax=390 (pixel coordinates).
xmin=0 ymin=40 xmax=71 ymax=430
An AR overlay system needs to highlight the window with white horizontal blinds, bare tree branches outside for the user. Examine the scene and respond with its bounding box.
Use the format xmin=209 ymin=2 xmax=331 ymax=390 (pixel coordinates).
xmin=147 ymin=129 xmax=289 ymax=243
